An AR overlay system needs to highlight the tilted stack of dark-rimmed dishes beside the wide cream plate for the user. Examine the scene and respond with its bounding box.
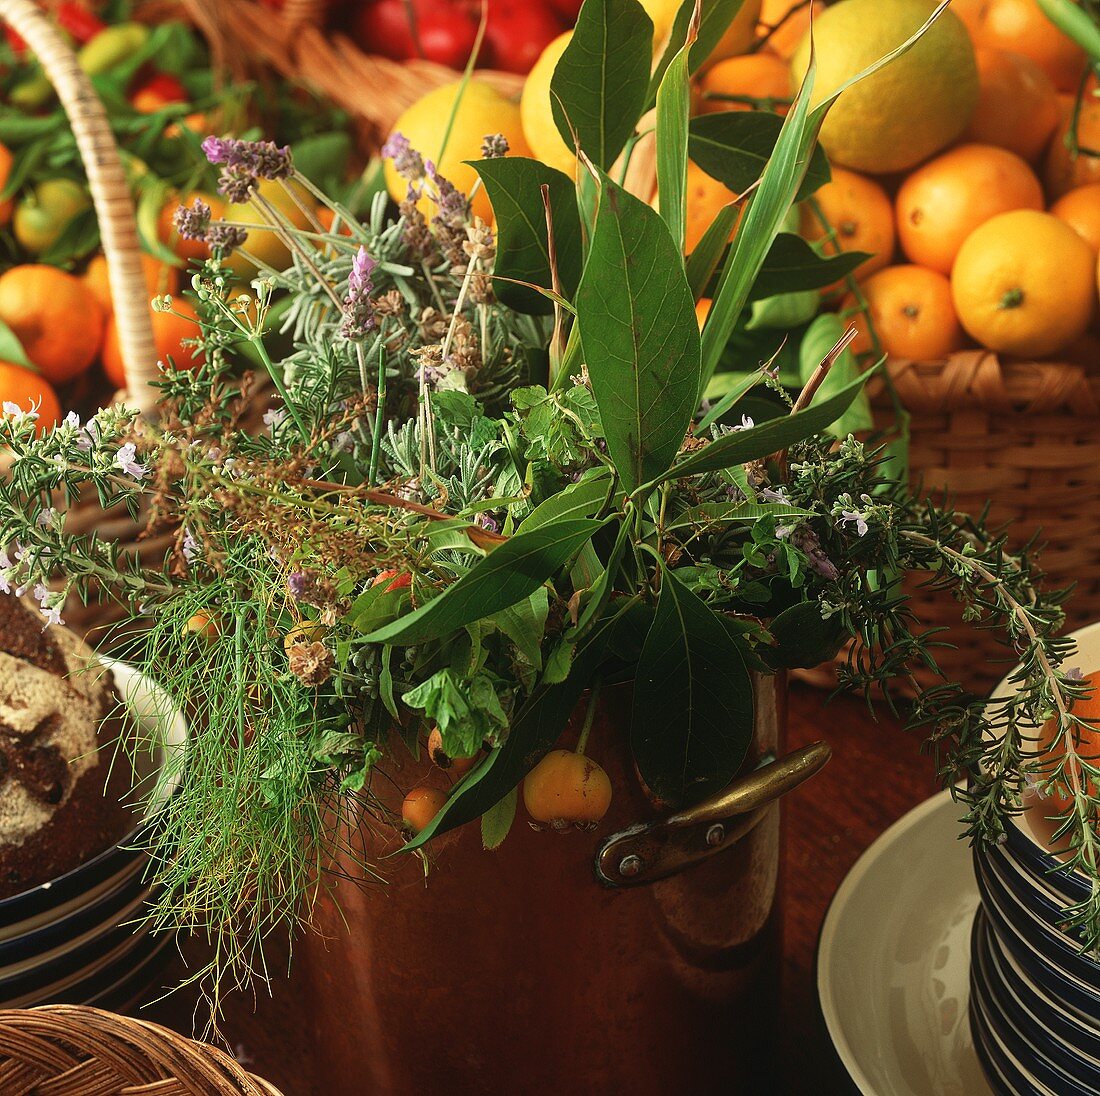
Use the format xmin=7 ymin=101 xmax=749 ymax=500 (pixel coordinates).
xmin=970 ymin=625 xmax=1100 ymax=1096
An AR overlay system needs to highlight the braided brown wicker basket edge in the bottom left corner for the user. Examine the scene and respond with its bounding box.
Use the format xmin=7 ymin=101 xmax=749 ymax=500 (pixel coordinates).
xmin=0 ymin=1005 xmax=281 ymax=1096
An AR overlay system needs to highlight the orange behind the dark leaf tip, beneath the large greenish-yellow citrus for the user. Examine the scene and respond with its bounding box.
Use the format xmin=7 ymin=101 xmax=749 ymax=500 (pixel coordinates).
xmin=801 ymin=167 xmax=894 ymax=277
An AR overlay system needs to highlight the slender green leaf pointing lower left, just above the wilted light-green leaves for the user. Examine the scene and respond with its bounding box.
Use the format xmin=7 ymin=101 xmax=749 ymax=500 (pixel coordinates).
xmin=366 ymin=519 xmax=602 ymax=645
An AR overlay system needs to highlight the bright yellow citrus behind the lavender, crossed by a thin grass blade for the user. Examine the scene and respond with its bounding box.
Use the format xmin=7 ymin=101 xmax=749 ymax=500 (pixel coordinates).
xmin=385 ymin=79 xmax=530 ymax=221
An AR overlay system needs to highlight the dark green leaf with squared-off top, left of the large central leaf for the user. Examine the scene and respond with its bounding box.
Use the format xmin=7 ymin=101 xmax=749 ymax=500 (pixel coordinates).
xmin=469 ymin=156 xmax=583 ymax=316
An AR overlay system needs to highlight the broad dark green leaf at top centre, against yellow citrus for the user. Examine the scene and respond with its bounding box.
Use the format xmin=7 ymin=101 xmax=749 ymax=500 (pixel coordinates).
xmin=550 ymin=0 xmax=653 ymax=171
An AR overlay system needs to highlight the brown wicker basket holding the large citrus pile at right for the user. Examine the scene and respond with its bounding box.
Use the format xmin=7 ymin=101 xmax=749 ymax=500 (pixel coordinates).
xmin=800 ymin=350 xmax=1100 ymax=692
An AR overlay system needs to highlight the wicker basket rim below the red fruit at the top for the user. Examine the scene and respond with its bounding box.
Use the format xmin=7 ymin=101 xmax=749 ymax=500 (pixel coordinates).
xmin=173 ymin=0 xmax=524 ymax=147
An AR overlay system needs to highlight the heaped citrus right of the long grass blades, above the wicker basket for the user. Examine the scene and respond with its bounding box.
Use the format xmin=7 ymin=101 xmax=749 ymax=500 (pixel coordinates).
xmin=793 ymin=0 xmax=1100 ymax=363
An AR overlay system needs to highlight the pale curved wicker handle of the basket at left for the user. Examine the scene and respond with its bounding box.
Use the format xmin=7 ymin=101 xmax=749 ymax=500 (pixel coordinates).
xmin=0 ymin=0 xmax=157 ymax=413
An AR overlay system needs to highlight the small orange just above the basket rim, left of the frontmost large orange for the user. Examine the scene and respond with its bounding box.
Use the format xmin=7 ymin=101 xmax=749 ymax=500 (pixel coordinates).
xmin=840 ymin=265 xmax=963 ymax=361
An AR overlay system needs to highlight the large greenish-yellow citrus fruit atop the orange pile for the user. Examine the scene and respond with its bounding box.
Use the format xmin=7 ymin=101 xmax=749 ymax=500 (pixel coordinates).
xmin=791 ymin=0 xmax=978 ymax=174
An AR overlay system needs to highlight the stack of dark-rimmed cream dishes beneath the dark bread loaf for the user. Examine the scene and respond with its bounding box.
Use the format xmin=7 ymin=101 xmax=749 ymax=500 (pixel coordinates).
xmin=0 ymin=659 xmax=186 ymax=1009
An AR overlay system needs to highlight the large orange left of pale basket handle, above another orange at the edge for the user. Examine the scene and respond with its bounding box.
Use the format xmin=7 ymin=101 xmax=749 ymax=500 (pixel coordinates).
xmin=0 ymin=263 xmax=105 ymax=384
